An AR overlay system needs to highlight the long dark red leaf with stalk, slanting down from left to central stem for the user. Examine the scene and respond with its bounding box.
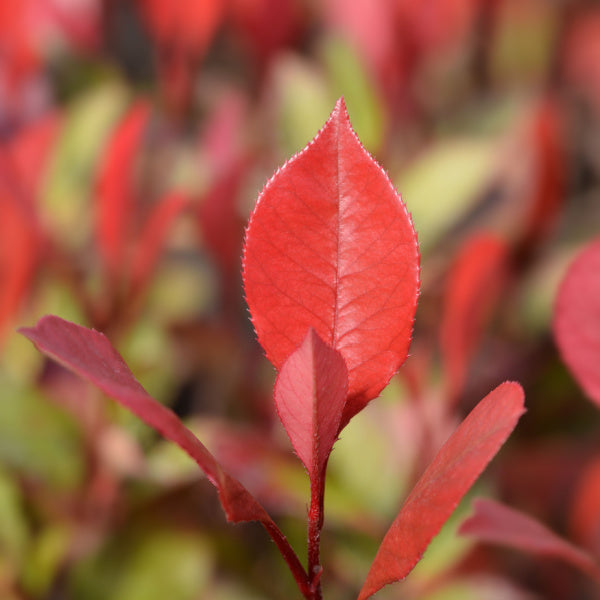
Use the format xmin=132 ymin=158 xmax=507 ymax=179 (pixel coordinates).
xmin=19 ymin=316 xmax=307 ymax=588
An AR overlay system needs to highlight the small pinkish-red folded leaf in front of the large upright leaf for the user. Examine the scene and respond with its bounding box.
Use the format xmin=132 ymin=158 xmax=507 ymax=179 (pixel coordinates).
xmin=275 ymin=329 xmax=348 ymax=482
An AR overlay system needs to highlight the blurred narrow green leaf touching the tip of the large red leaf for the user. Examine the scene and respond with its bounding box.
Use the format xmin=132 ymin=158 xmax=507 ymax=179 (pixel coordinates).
xmin=321 ymin=38 xmax=385 ymax=152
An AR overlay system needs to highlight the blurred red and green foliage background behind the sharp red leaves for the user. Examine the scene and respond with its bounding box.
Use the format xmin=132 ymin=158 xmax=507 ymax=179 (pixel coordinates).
xmin=0 ymin=0 xmax=600 ymax=600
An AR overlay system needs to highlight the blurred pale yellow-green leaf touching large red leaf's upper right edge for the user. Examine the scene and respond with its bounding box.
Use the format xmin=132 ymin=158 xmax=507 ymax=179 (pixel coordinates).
xmin=396 ymin=139 xmax=498 ymax=252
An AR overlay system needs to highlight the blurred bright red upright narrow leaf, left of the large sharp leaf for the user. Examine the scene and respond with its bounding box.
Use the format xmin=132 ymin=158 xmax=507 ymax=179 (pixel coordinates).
xmin=97 ymin=101 xmax=150 ymax=278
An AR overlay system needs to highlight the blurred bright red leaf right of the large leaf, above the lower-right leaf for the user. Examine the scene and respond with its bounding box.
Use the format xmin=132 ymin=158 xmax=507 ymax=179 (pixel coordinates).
xmin=440 ymin=233 xmax=508 ymax=399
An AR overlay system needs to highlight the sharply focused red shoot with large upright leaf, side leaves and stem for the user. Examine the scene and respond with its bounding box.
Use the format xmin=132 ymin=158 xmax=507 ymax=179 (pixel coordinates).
xmin=21 ymin=99 xmax=524 ymax=600
